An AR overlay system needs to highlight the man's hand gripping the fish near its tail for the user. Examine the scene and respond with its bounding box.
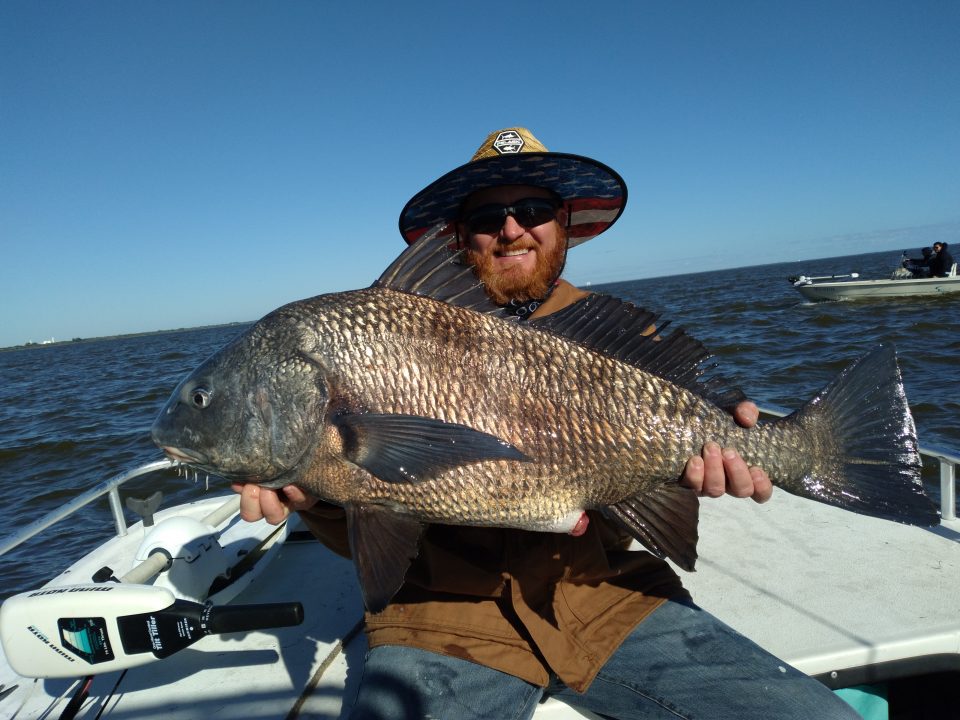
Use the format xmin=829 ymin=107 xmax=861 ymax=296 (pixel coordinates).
xmin=680 ymin=401 xmax=773 ymax=503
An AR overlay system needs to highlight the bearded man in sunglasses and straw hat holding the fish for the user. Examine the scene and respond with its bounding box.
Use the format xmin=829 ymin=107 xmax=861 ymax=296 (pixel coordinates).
xmin=237 ymin=128 xmax=856 ymax=720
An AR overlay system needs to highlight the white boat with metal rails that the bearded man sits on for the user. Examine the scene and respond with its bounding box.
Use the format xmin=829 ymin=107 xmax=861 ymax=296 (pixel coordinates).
xmin=0 ymin=407 xmax=960 ymax=720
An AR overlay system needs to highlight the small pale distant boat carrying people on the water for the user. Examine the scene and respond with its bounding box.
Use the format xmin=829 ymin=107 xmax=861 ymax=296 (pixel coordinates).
xmin=787 ymin=263 xmax=960 ymax=300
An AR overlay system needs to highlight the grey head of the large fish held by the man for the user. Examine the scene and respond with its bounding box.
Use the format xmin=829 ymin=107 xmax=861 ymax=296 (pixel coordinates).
xmin=151 ymin=308 xmax=328 ymax=487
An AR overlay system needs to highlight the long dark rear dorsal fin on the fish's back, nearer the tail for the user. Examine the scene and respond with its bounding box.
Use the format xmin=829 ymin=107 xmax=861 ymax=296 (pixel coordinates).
xmin=530 ymin=293 xmax=746 ymax=408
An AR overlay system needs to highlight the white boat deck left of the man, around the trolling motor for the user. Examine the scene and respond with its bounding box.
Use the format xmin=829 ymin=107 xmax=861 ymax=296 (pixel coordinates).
xmin=0 ymin=496 xmax=589 ymax=720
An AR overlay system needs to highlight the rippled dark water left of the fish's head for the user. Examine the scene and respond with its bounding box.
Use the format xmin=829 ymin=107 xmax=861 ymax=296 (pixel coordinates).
xmin=0 ymin=326 xmax=248 ymax=597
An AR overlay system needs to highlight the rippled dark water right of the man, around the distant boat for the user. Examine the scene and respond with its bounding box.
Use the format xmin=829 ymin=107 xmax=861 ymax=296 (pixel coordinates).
xmin=599 ymin=252 xmax=960 ymax=450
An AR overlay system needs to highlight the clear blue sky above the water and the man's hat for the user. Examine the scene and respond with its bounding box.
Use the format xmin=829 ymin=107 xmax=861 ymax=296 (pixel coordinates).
xmin=0 ymin=0 xmax=960 ymax=346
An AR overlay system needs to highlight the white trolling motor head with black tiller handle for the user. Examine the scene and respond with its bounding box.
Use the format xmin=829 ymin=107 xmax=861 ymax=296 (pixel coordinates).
xmin=0 ymin=583 xmax=303 ymax=678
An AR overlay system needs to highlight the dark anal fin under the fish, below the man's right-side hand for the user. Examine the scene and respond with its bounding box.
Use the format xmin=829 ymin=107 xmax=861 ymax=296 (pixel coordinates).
xmin=604 ymin=484 xmax=700 ymax=571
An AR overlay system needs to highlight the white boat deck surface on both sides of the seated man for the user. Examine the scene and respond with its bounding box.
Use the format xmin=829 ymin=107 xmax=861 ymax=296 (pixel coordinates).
xmin=0 ymin=491 xmax=960 ymax=720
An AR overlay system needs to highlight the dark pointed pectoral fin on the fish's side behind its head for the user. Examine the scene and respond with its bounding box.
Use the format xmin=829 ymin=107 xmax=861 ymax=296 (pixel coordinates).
xmin=334 ymin=413 xmax=530 ymax=483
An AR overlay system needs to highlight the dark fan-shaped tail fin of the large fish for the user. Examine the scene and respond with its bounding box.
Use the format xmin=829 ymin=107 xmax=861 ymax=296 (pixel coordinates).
xmin=778 ymin=345 xmax=940 ymax=526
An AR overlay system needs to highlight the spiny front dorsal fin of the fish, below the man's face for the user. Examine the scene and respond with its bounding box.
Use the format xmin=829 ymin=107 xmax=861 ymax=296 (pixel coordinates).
xmin=373 ymin=225 xmax=516 ymax=320
